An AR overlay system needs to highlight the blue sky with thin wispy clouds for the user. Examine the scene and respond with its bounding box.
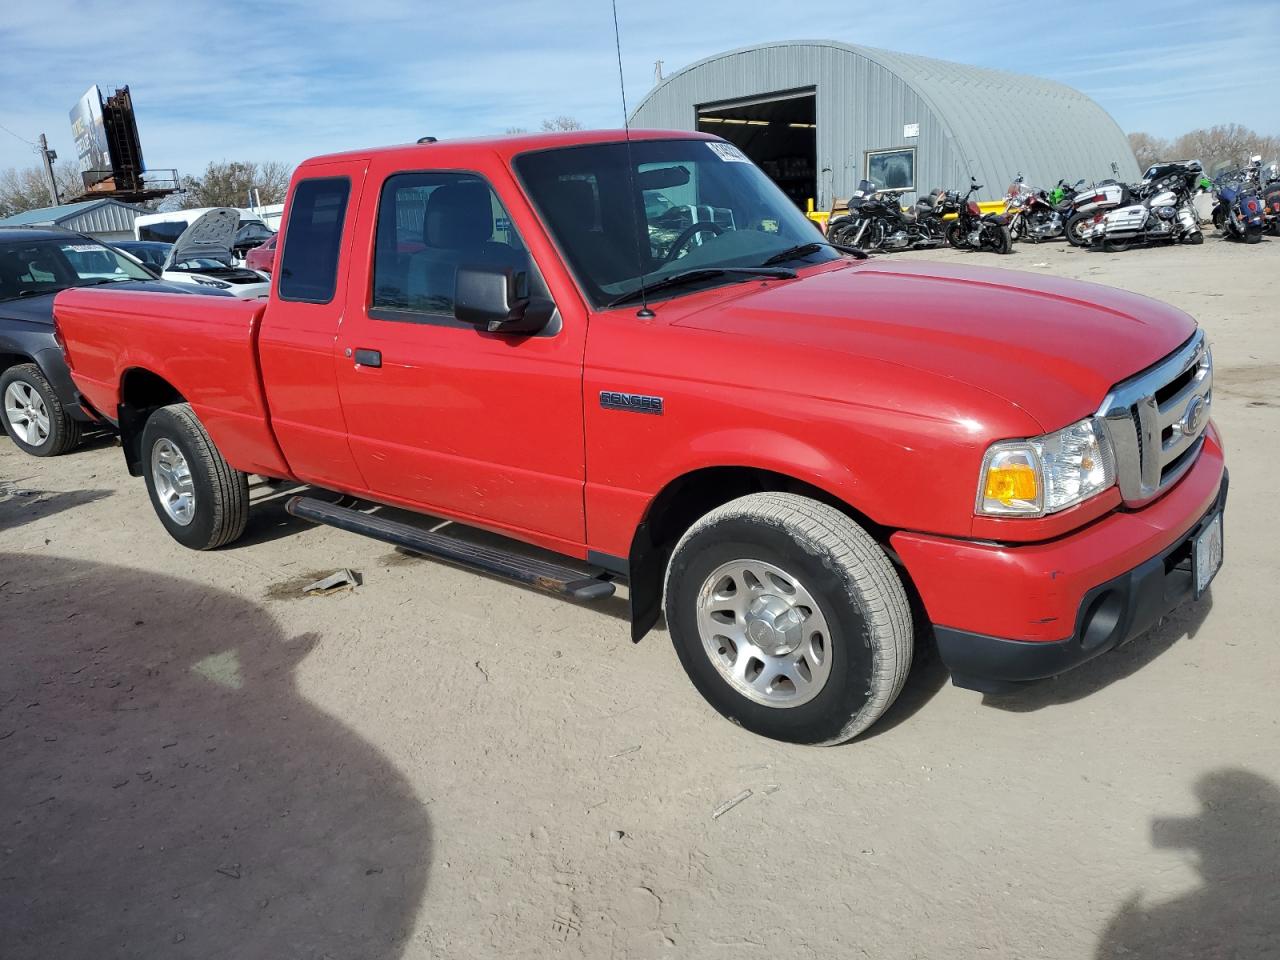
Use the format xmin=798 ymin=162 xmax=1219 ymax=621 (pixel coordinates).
xmin=0 ymin=0 xmax=1280 ymax=173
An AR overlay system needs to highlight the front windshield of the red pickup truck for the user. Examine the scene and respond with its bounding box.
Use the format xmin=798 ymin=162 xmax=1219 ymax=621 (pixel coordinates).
xmin=515 ymin=140 xmax=838 ymax=306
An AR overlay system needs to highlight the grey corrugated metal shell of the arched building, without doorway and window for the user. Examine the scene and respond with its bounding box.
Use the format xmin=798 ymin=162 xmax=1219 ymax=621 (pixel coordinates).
xmin=631 ymin=41 xmax=1139 ymax=209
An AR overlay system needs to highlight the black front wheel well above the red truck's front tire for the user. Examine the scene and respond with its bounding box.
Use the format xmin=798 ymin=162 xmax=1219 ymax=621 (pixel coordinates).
xmin=627 ymin=467 xmax=888 ymax=640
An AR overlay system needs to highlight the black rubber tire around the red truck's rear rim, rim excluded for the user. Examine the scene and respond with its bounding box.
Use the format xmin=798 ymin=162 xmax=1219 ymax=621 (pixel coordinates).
xmin=142 ymin=403 xmax=248 ymax=550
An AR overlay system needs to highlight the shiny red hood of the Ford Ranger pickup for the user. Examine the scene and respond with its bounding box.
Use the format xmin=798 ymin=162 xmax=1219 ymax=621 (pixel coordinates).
xmin=676 ymin=261 xmax=1196 ymax=431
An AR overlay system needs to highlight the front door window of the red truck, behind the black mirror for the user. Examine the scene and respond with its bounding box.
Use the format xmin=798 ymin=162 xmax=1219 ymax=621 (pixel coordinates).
xmin=370 ymin=173 xmax=545 ymax=321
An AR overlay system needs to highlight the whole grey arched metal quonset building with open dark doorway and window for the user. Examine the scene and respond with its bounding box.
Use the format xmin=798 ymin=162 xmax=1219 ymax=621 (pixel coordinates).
xmin=631 ymin=40 xmax=1139 ymax=209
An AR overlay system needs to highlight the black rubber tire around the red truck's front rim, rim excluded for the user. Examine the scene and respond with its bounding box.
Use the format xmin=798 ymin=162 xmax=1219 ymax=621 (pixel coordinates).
xmin=666 ymin=493 xmax=913 ymax=744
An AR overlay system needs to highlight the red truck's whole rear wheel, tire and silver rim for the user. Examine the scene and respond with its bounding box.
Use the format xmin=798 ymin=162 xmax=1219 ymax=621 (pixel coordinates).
xmin=142 ymin=403 xmax=248 ymax=550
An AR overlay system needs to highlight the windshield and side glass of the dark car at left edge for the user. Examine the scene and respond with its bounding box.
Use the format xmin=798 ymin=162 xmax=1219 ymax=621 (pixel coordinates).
xmin=0 ymin=237 xmax=155 ymax=300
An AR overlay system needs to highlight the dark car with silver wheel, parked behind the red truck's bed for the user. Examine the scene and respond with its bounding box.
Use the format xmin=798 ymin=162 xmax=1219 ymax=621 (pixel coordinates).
xmin=0 ymin=227 xmax=217 ymax=457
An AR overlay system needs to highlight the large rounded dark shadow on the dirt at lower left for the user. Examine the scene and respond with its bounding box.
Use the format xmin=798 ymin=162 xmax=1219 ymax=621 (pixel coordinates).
xmin=0 ymin=554 xmax=430 ymax=960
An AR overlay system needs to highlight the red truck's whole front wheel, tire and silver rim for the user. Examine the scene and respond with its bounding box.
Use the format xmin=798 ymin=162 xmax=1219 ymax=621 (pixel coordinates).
xmin=666 ymin=493 xmax=913 ymax=744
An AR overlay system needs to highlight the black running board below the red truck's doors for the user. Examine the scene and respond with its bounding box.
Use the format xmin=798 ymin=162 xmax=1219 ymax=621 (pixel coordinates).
xmin=284 ymin=497 xmax=616 ymax=600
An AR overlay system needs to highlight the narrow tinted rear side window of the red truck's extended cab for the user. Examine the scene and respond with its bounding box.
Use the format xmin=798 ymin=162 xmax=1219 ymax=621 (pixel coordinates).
xmin=279 ymin=177 xmax=351 ymax=303
